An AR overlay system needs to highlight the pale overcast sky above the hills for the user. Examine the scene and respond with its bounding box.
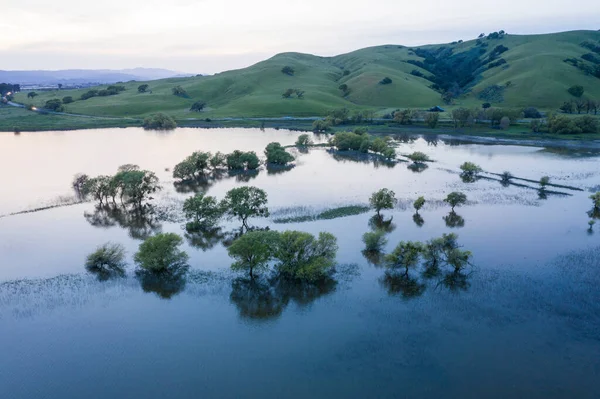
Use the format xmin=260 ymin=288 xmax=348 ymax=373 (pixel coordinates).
xmin=0 ymin=0 xmax=600 ymax=73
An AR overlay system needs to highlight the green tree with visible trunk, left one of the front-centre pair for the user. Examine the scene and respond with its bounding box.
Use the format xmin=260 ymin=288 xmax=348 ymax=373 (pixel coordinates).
xmin=227 ymin=231 xmax=278 ymax=279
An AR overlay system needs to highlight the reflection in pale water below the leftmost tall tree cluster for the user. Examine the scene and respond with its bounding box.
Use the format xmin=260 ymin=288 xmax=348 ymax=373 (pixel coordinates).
xmin=83 ymin=204 xmax=162 ymax=240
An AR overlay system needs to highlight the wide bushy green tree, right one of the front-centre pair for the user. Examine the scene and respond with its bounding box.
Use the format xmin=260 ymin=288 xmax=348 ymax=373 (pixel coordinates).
xmin=275 ymin=231 xmax=338 ymax=282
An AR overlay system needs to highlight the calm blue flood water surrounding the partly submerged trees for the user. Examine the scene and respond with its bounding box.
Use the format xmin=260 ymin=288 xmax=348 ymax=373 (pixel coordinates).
xmin=0 ymin=129 xmax=600 ymax=399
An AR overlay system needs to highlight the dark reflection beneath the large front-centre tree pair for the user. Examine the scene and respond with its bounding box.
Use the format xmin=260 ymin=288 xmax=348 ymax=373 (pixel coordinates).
xmin=229 ymin=277 xmax=337 ymax=321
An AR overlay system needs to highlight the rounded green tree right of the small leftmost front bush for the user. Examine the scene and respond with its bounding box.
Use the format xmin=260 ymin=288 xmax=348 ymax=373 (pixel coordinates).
xmin=134 ymin=233 xmax=189 ymax=273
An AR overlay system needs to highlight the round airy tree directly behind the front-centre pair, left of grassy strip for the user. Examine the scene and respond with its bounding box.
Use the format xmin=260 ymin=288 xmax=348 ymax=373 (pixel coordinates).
xmin=222 ymin=186 xmax=269 ymax=229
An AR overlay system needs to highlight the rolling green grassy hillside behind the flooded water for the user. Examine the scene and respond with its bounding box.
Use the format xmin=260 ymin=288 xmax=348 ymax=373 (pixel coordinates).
xmin=15 ymin=31 xmax=600 ymax=120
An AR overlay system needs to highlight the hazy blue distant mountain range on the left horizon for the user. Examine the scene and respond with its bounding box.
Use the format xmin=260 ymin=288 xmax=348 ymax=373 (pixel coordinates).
xmin=0 ymin=68 xmax=192 ymax=85
